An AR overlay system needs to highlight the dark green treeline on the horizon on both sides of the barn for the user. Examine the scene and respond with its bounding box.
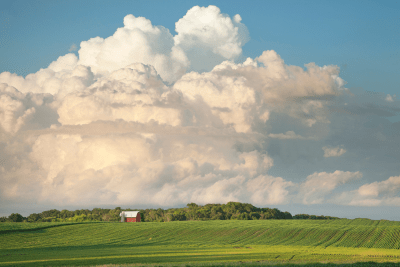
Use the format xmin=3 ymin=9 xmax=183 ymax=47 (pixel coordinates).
xmin=0 ymin=202 xmax=339 ymax=222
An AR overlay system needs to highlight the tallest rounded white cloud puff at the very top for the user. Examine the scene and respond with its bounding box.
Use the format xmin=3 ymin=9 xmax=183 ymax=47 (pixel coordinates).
xmin=174 ymin=6 xmax=249 ymax=71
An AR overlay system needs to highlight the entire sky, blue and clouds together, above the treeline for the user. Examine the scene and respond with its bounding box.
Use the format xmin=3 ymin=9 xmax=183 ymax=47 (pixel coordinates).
xmin=0 ymin=0 xmax=400 ymax=220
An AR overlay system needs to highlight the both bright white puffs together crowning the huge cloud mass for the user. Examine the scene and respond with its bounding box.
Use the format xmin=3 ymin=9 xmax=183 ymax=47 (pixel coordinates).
xmin=78 ymin=6 xmax=248 ymax=82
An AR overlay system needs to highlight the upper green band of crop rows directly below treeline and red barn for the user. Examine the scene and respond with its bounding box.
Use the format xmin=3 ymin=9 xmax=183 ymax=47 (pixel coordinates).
xmin=0 ymin=220 xmax=400 ymax=249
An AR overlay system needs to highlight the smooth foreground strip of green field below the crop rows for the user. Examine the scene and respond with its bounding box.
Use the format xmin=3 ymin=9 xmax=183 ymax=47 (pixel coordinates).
xmin=0 ymin=241 xmax=400 ymax=267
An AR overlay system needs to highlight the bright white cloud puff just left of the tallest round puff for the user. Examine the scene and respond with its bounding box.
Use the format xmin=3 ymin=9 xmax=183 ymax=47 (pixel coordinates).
xmin=78 ymin=15 xmax=189 ymax=84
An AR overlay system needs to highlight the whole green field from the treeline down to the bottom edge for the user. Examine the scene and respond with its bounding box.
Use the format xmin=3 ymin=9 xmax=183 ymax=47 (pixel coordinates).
xmin=0 ymin=219 xmax=400 ymax=267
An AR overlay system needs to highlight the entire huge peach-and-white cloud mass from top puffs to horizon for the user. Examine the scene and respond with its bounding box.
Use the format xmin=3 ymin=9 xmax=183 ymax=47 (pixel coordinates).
xmin=0 ymin=6 xmax=398 ymax=215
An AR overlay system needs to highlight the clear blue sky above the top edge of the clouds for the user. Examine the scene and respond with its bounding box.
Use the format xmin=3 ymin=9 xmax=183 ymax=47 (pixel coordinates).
xmin=0 ymin=1 xmax=400 ymax=103
